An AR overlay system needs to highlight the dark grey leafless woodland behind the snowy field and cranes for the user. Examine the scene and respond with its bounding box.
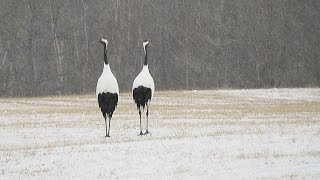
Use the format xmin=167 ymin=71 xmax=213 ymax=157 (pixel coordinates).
xmin=0 ymin=0 xmax=320 ymax=97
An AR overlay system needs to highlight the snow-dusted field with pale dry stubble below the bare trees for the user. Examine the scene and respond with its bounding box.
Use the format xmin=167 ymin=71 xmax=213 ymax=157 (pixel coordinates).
xmin=0 ymin=89 xmax=320 ymax=179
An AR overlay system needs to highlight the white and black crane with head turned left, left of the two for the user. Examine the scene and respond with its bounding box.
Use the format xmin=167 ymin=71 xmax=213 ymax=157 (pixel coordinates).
xmin=96 ymin=39 xmax=119 ymax=137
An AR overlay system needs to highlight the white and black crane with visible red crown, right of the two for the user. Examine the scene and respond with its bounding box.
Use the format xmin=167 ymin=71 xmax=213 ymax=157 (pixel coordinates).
xmin=132 ymin=40 xmax=154 ymax=136
